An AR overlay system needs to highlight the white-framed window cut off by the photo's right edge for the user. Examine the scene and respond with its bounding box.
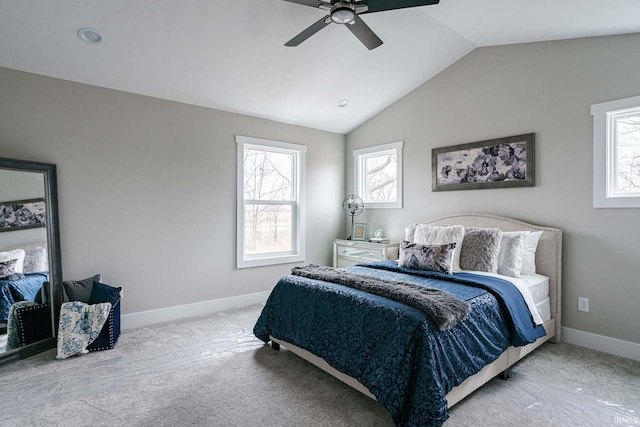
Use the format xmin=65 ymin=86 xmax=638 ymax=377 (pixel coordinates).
xmin=591 ymin=96 xmax=640 ymax=208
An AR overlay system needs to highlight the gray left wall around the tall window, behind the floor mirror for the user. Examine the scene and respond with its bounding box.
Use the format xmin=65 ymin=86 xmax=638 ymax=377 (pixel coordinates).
xmin=0 ymin=69 xmax=345 ymax=313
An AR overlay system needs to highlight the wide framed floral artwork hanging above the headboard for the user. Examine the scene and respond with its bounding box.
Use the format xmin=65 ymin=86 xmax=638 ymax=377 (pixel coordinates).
xmin=431 ymin=133 xmax=535 ymax=191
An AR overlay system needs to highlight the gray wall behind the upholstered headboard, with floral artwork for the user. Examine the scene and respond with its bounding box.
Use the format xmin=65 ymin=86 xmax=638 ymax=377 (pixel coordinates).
xmin=347 ymin=34 xmax=640 ymax=343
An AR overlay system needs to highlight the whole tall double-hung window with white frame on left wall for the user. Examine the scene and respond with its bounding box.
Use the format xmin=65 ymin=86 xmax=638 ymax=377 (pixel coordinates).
xmin=236 ymin=135 xmax=306 ymax=268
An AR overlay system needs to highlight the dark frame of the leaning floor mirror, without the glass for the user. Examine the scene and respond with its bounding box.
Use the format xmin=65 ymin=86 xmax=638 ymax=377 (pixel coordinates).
xmin=0 ymin=157 xmax=62 ymax=366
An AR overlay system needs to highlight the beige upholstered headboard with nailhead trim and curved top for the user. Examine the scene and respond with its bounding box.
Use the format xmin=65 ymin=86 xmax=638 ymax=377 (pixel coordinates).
xmin=423 ymin=213 xmax=562 ymax=342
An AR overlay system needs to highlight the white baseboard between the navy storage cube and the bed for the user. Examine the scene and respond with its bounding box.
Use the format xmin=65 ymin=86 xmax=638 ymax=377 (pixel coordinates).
xmin=121 ymin=291 xmax=271 ymax=329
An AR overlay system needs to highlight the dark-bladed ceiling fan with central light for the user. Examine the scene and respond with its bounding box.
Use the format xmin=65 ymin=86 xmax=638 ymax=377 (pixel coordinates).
xmin=284 ymin=0 xmax=440 ymax=50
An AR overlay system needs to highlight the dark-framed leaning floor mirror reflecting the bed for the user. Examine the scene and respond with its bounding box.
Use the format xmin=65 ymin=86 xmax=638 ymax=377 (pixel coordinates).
xmin=0 ymin=157 xmax=62 ymax=365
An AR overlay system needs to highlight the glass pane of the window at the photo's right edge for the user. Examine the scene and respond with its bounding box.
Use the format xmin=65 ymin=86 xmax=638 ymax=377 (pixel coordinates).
xmin=615 ymin=114 xmax=640 ymax=194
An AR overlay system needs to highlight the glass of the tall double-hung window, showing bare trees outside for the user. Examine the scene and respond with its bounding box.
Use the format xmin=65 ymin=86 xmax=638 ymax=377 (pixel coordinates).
xmin=244 ymin=148 xmax=295 ymax=254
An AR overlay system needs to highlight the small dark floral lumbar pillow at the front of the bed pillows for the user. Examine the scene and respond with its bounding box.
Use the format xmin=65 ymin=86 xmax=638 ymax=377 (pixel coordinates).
xmin=398 ymin=240 xmax=456 ymax=274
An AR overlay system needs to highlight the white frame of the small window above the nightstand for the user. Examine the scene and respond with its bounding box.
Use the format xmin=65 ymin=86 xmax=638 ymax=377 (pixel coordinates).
xmin=353 ymin=141 xmax=404 ymax=209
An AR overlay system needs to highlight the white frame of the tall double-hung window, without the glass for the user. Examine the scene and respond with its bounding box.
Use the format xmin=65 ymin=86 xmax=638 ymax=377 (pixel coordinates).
xmin=236 ymin=135 xmax=307 ymax=269
